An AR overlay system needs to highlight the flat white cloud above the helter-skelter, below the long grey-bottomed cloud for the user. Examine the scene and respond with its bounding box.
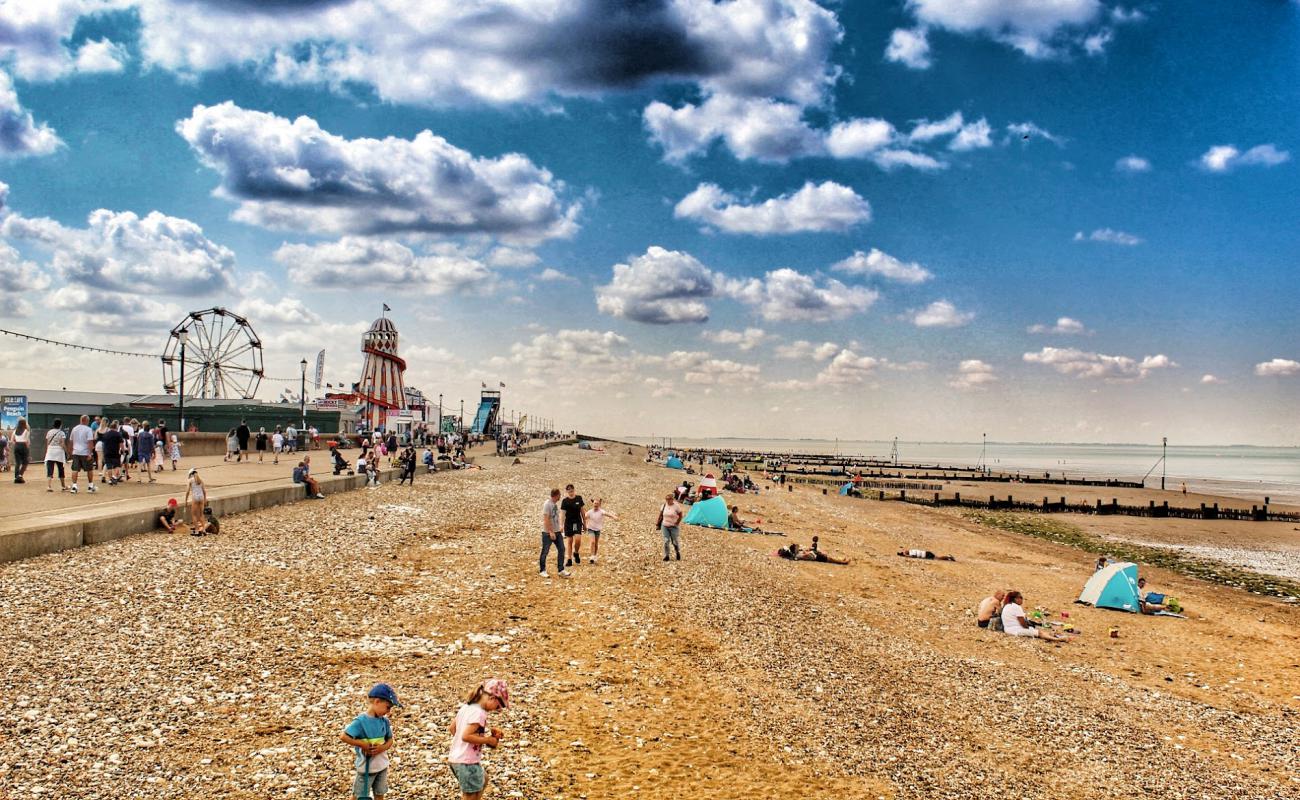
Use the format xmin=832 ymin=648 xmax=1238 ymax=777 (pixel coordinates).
xmin=274 ymin=237 xmax=494 ymax=295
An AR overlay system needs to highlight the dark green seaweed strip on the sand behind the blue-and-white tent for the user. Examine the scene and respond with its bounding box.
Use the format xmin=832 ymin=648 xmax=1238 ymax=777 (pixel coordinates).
xmin=962 ymin=511 xmax=1300 ymax=602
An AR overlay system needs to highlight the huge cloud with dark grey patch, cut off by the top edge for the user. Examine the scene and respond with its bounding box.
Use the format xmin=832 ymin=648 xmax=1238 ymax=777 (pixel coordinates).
xmin=138 ymin=0 xmax=842 ymax=105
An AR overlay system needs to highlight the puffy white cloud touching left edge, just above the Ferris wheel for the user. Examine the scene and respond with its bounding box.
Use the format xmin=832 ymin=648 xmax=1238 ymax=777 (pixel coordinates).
xmin=0 ymin=208 xmax=235 ymax=295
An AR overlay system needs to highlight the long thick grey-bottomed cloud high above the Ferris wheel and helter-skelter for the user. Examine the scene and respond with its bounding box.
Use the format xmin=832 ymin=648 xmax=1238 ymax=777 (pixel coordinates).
xmin=176 ymin=101 xmax=579 ymax=242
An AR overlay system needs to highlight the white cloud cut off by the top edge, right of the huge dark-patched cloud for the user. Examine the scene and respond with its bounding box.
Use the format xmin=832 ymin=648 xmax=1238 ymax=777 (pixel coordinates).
xmin=907 ymin=0 xmax=1106 ymax=59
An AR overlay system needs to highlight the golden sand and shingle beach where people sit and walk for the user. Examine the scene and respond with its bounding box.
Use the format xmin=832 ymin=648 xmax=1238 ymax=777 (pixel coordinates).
xmin=0 ymin=445 xmax=1300 ymax=799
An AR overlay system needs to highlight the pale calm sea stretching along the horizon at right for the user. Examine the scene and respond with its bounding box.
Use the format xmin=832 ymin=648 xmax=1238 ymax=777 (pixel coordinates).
xmin=623 ymin=436 xmax=1300 ymax=505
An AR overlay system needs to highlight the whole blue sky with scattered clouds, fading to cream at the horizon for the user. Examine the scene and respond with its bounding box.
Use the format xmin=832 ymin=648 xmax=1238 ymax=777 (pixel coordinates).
xmin=0 ymin=0 xmax=1300 ymax=444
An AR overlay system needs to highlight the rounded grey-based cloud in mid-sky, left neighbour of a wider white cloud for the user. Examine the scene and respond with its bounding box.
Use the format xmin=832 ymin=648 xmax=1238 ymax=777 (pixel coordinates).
xmin=595 ymin=247 xmax=719 ymax=325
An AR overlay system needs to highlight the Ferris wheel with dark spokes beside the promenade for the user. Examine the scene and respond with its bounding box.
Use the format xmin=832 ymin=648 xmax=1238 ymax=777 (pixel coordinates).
xmin=163 ymin=308 xmax=263 ymax=399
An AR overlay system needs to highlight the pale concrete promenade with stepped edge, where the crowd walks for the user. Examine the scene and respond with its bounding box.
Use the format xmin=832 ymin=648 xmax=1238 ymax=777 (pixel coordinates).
xmin=0 ymin=440 xmax=571 ymax=563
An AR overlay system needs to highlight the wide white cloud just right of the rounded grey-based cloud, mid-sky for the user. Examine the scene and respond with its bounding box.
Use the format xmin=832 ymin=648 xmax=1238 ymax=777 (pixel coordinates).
xmin=725 ymin=268 xmax=880 ymax=323
